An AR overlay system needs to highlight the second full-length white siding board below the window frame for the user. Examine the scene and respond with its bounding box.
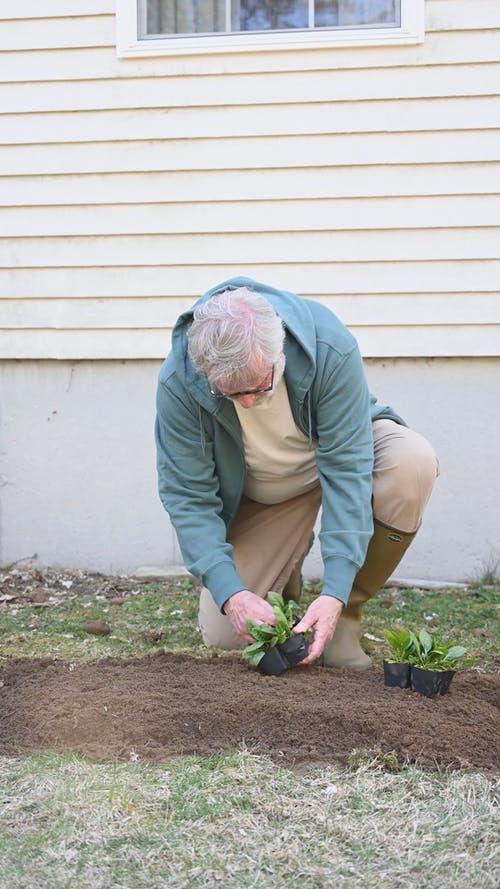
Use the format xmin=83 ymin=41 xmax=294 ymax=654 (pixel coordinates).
xmin=0 ymin=97 xmax=500 ymax=145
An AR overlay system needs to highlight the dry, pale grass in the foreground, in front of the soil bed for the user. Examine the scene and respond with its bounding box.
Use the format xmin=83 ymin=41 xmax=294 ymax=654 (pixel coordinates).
xmin=0 ymin=749 xmax=497 ymax=889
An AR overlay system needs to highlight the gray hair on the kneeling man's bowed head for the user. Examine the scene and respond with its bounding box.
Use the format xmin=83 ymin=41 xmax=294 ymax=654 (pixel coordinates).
xmin=188 ymin=287 xmax=285 ymax=388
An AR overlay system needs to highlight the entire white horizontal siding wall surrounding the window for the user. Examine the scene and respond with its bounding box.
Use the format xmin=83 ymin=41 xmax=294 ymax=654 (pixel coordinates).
xmin=0 ymin=0 xmax=500 ymax=358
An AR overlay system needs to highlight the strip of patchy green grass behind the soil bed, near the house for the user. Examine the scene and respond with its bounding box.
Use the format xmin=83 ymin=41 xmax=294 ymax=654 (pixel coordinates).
xmin=0 ymin=578 xmax=500 ymax=670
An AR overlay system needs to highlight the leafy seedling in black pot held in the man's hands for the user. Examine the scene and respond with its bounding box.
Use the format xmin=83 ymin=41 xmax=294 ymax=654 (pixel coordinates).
xmin=242 ymin=590 xmax=308 ymax=676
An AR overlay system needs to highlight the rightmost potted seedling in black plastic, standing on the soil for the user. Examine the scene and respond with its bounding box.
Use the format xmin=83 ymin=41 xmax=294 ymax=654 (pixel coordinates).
xmin=411 ymin=630 xmax=475 ymax=697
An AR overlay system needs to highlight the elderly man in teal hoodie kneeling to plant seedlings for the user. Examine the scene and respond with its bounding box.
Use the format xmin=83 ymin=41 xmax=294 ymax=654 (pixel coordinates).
xmin=156 ymin=278 xmax=437 ymax=668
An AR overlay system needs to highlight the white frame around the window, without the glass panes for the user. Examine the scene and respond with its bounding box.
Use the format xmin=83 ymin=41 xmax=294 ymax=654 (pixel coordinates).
xmin=116 ymin=0 xmax=424 ymax=59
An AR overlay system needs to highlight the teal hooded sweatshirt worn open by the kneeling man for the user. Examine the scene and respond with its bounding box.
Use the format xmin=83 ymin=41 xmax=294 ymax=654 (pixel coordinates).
xmin=155 ymin=277 xmax=404 ymax=609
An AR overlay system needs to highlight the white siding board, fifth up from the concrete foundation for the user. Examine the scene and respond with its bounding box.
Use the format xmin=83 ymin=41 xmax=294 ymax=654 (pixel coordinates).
xmin=0 ymin=195 xmax=500 ymax=236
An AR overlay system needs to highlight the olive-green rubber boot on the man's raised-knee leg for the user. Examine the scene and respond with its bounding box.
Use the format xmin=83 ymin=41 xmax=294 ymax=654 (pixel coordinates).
xmin=320 ymin=519 xmax=417 ymax=670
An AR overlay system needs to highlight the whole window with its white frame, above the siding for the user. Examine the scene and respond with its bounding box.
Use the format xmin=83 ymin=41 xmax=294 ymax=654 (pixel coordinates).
xmin=117 ymin=0 xmax=424 ymax=56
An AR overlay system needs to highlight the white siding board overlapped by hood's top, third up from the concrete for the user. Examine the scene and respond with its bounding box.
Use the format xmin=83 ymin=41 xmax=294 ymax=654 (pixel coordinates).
xmin=4 ymin=256 xmax=500 ymax=298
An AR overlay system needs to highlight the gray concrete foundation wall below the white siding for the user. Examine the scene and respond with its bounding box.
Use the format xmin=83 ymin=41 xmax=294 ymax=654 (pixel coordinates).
xmin=0 ymin=359 xmax=500 ymax=581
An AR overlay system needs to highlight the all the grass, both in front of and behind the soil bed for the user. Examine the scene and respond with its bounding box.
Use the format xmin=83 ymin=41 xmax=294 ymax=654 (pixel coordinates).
xmin=0 ymin=578 xmax=500 ymax=889
